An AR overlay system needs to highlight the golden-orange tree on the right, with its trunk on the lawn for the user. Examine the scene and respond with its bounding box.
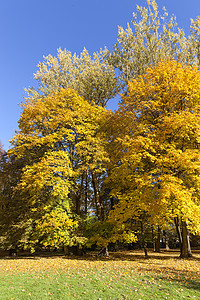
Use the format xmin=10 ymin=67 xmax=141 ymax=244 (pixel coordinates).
xmin=108 ymin=60 xmax=200 ymax=257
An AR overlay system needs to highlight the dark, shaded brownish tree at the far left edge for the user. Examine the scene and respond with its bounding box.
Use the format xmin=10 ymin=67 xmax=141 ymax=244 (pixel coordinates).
xmin=0 ymin=153 xmax=30 ymax=250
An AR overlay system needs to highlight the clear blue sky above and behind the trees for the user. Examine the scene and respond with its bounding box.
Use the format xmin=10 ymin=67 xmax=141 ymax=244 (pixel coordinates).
xmin=0 ymin=0 xmax=200 ymax=150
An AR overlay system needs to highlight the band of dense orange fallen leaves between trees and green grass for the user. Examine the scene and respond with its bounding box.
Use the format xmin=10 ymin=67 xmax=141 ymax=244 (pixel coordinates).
xmin=0 ymin=251 xmax=200 ymax=282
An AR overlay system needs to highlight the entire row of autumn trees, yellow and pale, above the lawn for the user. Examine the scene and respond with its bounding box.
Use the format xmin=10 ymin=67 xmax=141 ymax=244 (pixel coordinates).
xmin=0 ymin=0 xmax=200 ymax=257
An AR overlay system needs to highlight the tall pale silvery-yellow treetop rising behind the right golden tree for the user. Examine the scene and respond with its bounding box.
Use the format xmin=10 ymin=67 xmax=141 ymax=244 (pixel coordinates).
xmin=110 ymin=0 xmax=200 ymax=90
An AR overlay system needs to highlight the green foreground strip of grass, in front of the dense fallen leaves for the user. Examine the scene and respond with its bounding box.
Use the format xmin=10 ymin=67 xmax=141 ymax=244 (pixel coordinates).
xmin=0 ymin=271 xmax=200 ymax=300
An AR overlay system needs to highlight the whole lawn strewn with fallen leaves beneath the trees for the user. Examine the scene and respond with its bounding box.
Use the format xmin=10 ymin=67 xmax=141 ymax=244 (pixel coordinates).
xmin=0 ymin=251 xmax=200 ymax=300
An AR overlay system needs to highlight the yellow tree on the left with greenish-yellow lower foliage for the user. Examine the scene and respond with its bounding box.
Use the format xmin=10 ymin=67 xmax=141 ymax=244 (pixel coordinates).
xmin=3 ymin=89 xmax=107 ymax=249
